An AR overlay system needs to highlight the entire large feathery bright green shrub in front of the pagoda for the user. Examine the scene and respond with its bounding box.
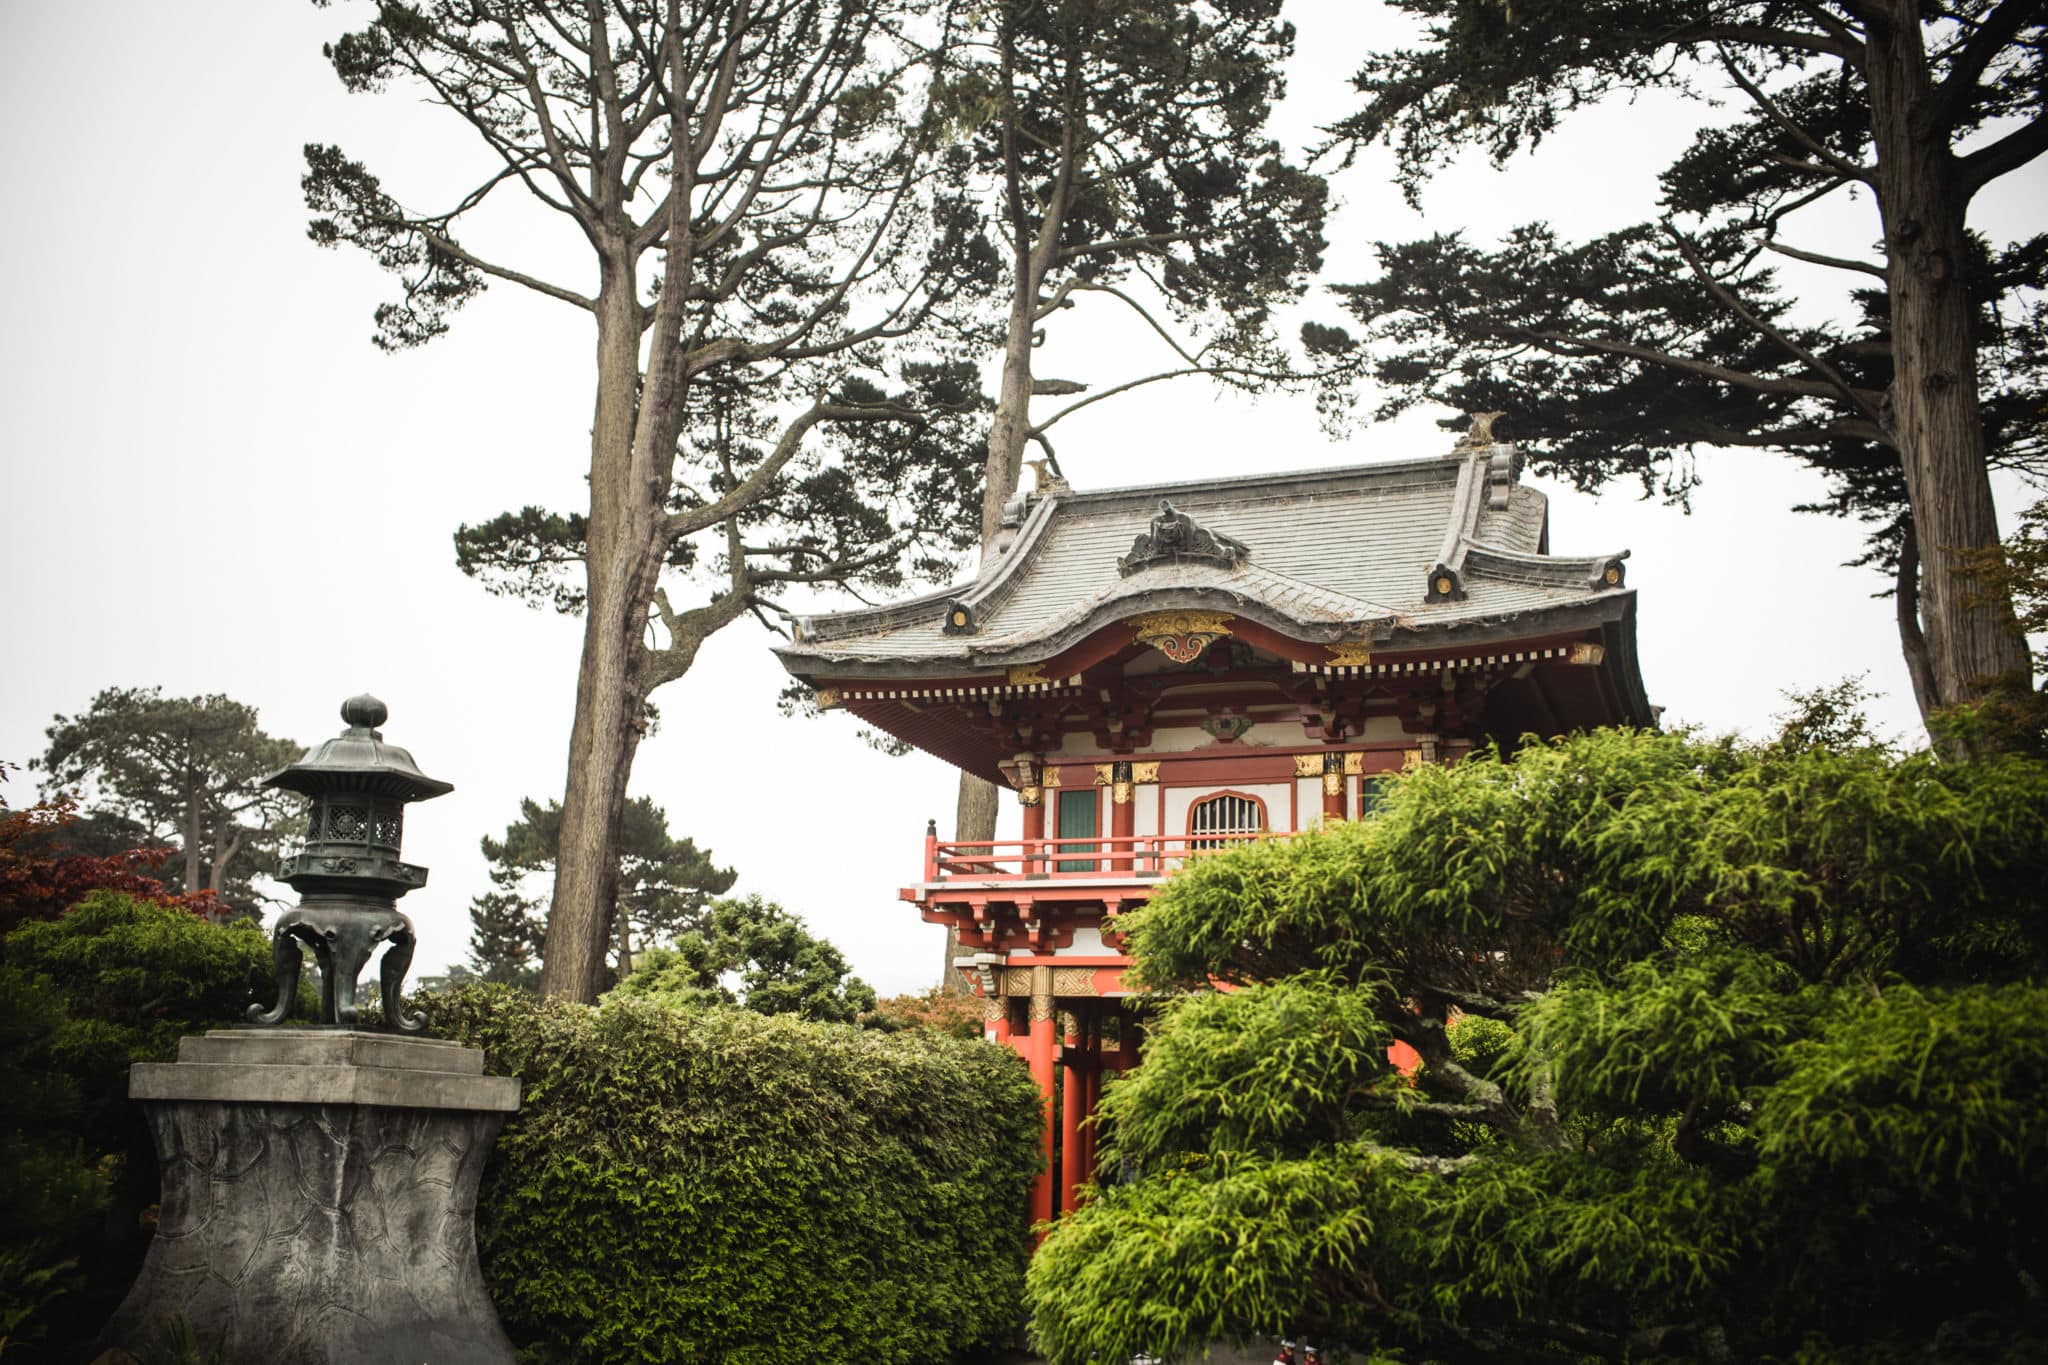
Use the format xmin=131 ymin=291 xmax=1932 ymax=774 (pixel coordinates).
xmin=1028 ymin=732 xmax=2048 ymax=1365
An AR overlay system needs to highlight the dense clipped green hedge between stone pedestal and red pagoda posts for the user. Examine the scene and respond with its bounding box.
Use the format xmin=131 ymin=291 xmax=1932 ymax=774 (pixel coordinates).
xmin=422 ymin=986 xmax=1038 ymax=1365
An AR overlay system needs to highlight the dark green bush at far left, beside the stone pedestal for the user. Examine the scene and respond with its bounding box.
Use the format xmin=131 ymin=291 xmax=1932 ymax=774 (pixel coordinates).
xmin=0 ymin=892 xmax=270 ymax=1361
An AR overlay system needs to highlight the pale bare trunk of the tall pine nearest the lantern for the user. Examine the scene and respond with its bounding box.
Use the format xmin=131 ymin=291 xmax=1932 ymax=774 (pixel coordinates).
xmin=541 ymin=266 xmax=666 ymax=1003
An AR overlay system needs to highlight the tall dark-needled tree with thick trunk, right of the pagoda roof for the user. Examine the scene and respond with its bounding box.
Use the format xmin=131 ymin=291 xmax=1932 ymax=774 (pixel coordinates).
xmin=1337 ymin=0 xmax=2048 ymax=736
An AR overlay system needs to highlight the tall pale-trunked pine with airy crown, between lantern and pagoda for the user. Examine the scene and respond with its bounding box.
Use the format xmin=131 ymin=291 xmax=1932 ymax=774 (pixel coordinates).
xmin=303 ymin=0 xmax=999 ymax=1001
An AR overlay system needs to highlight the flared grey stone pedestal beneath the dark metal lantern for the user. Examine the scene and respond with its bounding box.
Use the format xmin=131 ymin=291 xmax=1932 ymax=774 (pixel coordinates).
xmin=100 ymin=1029 xmax=518 ymax=1365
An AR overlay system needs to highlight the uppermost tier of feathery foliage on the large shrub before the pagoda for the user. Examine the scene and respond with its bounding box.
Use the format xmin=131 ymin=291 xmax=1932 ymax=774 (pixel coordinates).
xmin=1128 ymin=733 xmax=2048 ymax=1003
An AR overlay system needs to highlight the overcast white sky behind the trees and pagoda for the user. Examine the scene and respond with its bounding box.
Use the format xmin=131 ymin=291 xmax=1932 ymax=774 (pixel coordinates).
xmin=0 ymin=0 xmax=2048 ymax=995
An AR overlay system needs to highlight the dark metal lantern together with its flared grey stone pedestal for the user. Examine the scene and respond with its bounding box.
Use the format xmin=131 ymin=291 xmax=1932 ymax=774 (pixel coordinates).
xmin=100 ymin=696 xmax=518 ymax=1365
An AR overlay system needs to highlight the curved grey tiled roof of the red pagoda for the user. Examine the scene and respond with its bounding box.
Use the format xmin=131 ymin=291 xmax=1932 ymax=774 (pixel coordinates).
xmin=778 ymin=446 xmax=1628 ymax=677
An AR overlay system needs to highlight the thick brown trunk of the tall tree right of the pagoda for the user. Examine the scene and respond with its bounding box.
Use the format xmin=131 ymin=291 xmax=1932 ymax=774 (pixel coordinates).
xmin=1866 ymin=0 xmax=2028 ymax=724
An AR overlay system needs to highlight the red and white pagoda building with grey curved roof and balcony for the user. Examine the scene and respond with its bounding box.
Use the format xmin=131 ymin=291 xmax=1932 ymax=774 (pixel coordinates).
xmin=778 ymin=420 xmax=1655 ymax=1220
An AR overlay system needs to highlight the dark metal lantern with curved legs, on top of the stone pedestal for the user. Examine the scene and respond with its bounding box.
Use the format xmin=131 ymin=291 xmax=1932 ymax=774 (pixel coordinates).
xmin=250 ymin=694 xmax=455 ymax=1033
